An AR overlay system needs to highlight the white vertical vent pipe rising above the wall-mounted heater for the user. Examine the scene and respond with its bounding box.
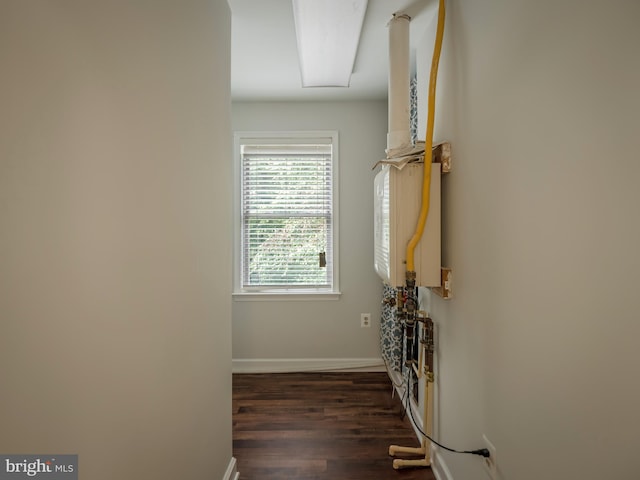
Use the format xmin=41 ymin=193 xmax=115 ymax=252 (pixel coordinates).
xmin=387 ymin=13 xmax=411 ymax=158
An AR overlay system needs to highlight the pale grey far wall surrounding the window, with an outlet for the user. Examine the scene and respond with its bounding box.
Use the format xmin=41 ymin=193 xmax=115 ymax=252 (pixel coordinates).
xmin=232 ymin=101 xmax=387 ymax=366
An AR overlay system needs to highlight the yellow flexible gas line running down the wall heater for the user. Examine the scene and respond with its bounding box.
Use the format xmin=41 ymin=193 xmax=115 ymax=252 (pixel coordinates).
xmin=407 ymin=0 xmax=445 ymax=272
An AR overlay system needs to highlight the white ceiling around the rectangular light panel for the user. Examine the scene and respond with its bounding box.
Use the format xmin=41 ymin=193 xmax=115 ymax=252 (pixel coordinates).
xmin=228 ymin=0 xmax=437 ymax=101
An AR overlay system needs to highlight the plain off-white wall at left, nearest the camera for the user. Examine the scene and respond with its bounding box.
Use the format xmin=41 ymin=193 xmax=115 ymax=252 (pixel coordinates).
xmin=0 ymin=0 xmax=232 ymax=480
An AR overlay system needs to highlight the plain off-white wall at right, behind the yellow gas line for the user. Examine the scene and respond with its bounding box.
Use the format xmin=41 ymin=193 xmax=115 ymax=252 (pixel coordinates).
xmin=421 ymin=0 xmax=640 ymax=480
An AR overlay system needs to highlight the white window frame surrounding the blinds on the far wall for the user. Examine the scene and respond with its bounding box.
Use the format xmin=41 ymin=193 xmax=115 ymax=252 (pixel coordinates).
xmin=233 ymin=130 xmax=340 ymax=300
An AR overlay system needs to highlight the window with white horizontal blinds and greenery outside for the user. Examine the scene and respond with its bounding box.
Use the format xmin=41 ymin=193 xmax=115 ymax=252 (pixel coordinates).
xmin=235 ymin=132 xmax=338 ymax=295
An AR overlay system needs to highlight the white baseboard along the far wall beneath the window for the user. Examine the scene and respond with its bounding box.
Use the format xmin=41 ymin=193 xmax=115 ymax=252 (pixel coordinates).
xmin=232 ymin=357 xmax=386 ymax=373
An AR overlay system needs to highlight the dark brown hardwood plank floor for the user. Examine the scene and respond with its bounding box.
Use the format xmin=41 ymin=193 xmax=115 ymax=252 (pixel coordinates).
xmin=233 ymin=373 xmax=435 ymax=480
